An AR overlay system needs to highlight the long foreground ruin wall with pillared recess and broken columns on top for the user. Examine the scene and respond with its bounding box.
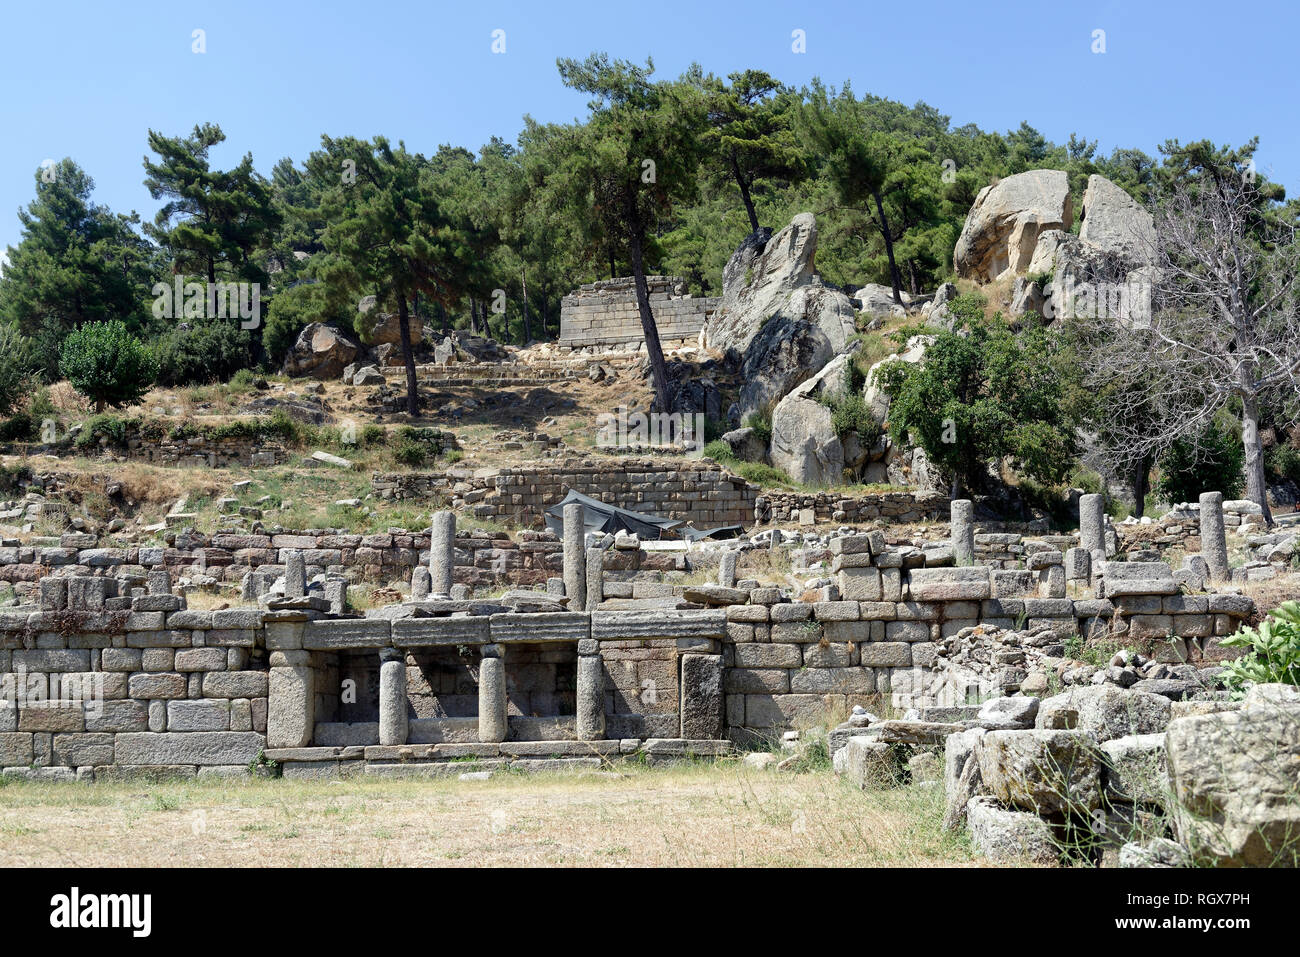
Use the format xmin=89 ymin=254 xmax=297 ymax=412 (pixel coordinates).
xmin=0 ymin=481 xmax=1255 ymax=778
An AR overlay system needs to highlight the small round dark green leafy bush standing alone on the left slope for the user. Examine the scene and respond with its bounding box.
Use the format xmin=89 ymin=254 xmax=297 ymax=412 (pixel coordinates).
xmin=59 ymin=320 xmax=159 ymax=412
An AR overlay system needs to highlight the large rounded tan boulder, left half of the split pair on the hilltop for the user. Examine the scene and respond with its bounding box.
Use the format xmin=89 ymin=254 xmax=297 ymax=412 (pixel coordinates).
xmin=953 ymin=169 xmax=1074 ymax=282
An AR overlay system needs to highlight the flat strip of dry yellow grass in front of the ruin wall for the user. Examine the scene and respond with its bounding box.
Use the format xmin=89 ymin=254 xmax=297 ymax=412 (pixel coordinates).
xmin=0 ymin=763 xmax=975 ymax=867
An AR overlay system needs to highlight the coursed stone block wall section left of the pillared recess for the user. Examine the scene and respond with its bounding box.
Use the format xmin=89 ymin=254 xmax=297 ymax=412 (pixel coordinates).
xmin=0 ymin=577 xmax=269 ymax=779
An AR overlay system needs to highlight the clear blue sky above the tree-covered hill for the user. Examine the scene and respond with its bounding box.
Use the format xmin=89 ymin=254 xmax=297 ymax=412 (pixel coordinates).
xmin=0 ymin=0 xmax=1300 ymax=256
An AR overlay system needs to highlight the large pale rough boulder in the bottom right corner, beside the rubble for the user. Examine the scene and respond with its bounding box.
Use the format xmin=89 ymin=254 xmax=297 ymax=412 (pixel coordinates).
xmin=1165 ymin=703 xmax=1300 ymax=867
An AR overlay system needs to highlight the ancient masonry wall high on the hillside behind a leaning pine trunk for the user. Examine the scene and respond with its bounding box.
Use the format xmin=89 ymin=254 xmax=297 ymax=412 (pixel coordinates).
xmin=559 ymin=276 xmax=722 ymax=350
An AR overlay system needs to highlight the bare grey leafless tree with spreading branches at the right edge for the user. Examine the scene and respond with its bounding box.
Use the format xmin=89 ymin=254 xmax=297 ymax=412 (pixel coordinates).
xmin=1086 ymin=176 xmax=1300 ymax=525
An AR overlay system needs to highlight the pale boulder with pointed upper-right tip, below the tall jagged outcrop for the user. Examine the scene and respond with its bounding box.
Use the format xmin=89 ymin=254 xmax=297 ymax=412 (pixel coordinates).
xmin=770 ymin=355 xmax=853 ymax=485
